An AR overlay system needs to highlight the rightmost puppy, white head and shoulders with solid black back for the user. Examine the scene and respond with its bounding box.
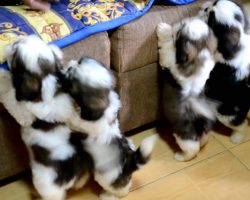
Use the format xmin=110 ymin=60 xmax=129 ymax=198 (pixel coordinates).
xmin=206 ymin=0 xmax=250 ymax=143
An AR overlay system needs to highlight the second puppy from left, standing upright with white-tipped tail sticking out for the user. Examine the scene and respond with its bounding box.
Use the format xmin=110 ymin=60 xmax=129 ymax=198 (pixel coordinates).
xmin=61 ymin=58 xmax=157 ymax=200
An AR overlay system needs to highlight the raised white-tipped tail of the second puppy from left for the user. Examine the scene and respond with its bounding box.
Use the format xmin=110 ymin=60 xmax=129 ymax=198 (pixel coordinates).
xmin=135 ymin=135 xmax=159 ymax=168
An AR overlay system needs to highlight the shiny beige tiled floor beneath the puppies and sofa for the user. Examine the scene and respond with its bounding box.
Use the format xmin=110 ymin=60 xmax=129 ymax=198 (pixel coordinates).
xmin=0 ymin=122 xmax=250 ymax=200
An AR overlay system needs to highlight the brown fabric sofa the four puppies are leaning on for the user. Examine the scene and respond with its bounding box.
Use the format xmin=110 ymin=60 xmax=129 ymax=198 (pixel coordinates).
xmin=0 ymin=0 xmax=247 ymax=181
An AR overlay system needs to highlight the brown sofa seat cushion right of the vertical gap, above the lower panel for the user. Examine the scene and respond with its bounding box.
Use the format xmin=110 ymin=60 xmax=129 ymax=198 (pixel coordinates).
xmin=111 ymin=0 xmax=205 ymax=72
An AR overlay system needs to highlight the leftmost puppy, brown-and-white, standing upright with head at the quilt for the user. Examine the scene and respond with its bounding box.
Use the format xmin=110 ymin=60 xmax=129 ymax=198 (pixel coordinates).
xmin=6 ymin=36 xmax=94 ymax=200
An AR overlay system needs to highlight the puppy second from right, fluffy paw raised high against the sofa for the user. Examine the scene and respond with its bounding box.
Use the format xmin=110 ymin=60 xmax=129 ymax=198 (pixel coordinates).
xmin=157 ymin=18 xmax=216 ymax=161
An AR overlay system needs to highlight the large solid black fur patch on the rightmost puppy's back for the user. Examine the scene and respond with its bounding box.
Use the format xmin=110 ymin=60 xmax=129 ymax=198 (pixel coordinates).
xmin=205 ymin=63 xmax=250 ymax=126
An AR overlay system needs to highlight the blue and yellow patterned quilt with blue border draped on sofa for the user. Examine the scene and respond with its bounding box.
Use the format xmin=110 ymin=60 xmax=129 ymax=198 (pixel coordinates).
xmin=0 ymin=0 xmax=154 ymax=68
